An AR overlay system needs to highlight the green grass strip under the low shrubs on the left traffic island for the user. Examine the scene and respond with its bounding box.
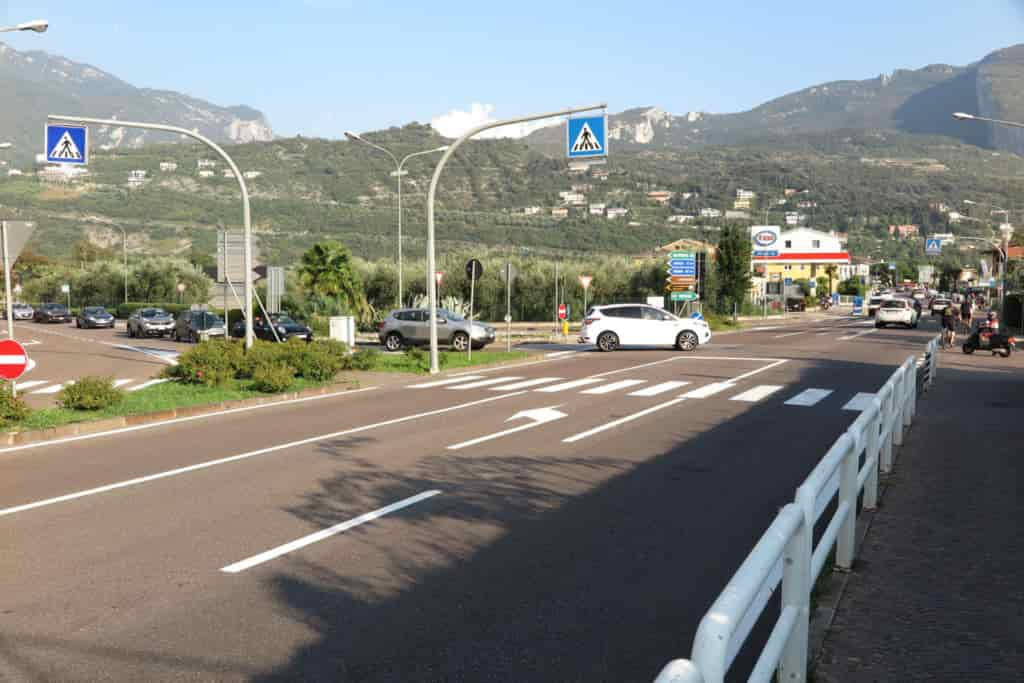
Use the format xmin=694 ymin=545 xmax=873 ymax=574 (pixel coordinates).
xmin=5 ymin=378 xmax=339 ymax=431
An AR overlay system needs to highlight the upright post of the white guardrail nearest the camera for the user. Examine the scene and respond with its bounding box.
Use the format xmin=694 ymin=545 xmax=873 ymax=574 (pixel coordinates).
xmin=778 ymin=506 xmax=813 ymax=683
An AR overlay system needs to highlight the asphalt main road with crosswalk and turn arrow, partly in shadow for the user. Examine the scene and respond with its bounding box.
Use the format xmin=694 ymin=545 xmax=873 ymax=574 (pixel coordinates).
xmin=0 ymin=315 xmax=937 ymax=681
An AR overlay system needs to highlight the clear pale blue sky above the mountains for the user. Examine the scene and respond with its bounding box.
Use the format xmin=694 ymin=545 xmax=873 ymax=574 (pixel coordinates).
xmin=0 ymin=0 xmax=1024 ymax=138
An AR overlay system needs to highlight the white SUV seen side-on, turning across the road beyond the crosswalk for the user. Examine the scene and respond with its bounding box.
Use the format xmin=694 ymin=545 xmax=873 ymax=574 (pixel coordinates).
xmin=580 ymin=303 xmax=711 ymax=351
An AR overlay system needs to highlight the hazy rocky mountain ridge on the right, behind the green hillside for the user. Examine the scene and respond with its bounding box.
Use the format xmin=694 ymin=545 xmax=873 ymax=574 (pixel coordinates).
xmin=527 ymin=45 xmax=1024 ymax=154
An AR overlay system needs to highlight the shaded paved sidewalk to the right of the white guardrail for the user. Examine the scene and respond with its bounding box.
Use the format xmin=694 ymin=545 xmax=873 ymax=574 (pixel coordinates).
xmin=811 ymin=351 xmax=1024 ymax=683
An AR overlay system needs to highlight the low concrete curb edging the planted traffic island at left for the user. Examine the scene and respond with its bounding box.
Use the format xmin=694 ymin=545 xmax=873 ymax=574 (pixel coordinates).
xmin=0 ymin=382 xmax=358 ymax=445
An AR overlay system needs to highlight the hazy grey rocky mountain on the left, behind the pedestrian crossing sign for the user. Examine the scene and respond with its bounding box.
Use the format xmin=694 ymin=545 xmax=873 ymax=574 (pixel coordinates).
xmin=0 ymin=43 xmax=273 ymax=163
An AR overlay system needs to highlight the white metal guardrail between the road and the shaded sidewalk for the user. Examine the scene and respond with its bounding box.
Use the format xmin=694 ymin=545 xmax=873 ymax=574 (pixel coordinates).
xmin=655 ymin=337 xmax=939 ymax=683
